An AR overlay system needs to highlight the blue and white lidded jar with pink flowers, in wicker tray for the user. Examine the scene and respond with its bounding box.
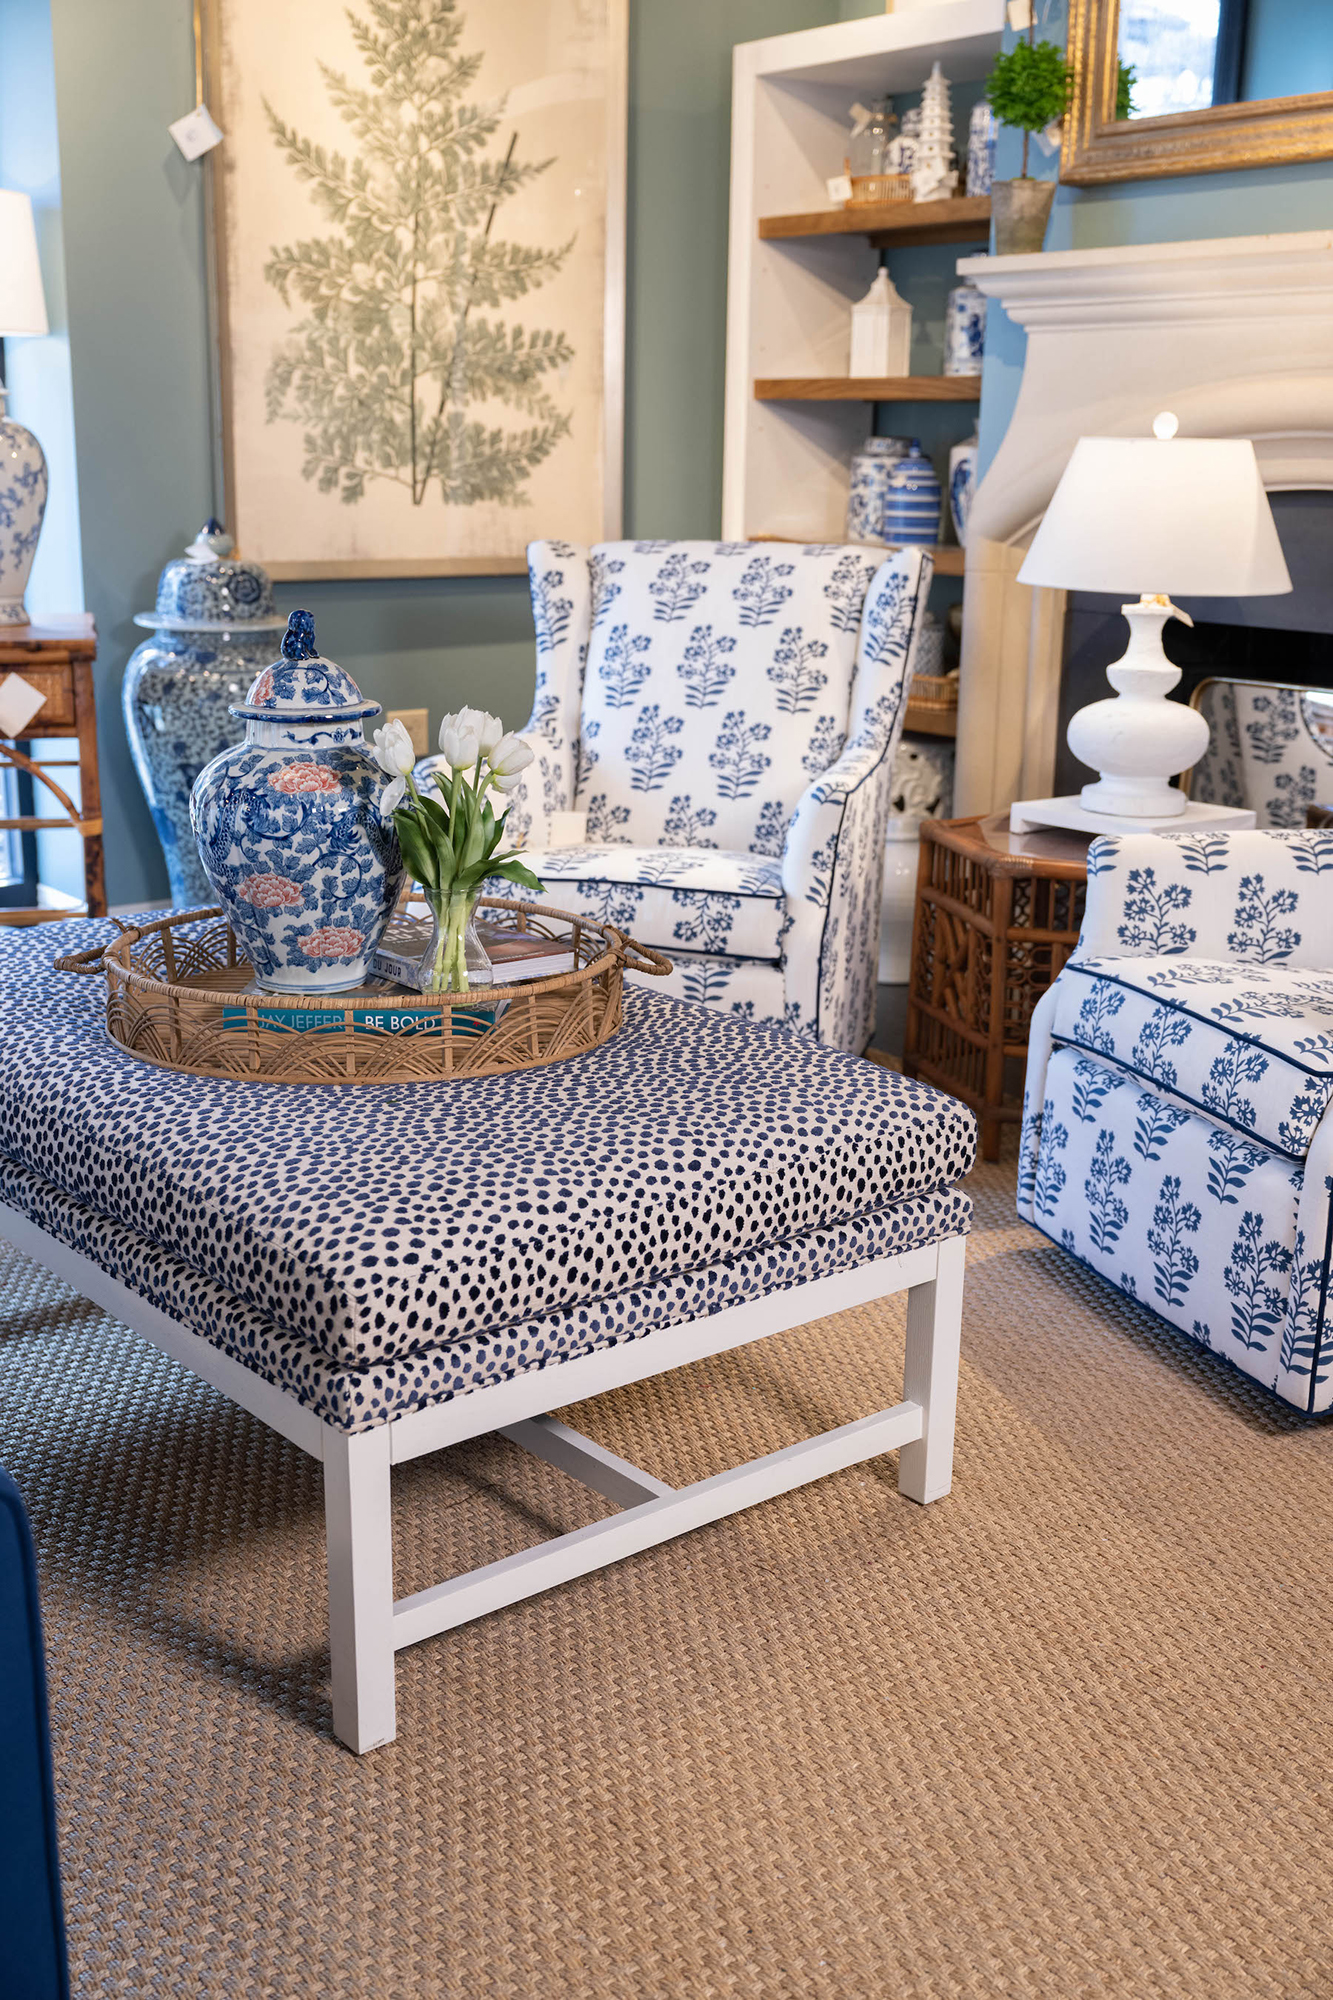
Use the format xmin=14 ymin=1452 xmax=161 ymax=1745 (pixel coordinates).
xmin=190 ymin=612 xmax=402 ymax=994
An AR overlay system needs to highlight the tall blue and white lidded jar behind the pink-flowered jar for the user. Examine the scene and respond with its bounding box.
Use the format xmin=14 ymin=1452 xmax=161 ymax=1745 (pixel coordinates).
xmin=120 ymin=520 xmax=286 ymax=908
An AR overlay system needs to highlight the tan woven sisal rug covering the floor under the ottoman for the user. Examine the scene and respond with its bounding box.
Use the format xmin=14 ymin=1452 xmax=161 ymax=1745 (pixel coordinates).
xmin=0 ymin=1166 xmax=1333 ymax=2000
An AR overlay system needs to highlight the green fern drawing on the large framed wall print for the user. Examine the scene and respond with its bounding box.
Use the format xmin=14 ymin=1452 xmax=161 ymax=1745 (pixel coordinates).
xmin=264 ymin=0 xmax=574 ymax=506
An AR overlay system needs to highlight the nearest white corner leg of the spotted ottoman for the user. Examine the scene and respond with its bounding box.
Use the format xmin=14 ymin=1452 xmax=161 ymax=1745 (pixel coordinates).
xmin=324 ymin=1426 xmax=396 ymax=1752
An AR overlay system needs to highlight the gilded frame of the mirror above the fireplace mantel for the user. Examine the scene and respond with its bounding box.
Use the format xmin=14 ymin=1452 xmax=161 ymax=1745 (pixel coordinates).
xmin=1061 ymin=0 xmax=1333 ymax=188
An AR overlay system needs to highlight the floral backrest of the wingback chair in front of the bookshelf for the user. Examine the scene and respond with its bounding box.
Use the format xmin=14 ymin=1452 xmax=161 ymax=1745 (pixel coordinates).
xmin=576 ymin=542 xmax=879 ymax=854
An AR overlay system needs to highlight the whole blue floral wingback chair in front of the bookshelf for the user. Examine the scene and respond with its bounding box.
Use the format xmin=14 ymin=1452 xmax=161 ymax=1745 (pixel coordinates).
xmin=462 ymin=542 xmax=931 ymax=1050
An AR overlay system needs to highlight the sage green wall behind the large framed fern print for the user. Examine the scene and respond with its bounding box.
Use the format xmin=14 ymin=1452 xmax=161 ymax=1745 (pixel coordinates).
xmin=50 ymin=0 xmax=839 ymax=904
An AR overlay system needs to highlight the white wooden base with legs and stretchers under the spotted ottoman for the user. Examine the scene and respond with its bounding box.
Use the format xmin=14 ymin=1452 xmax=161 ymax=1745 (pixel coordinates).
xmin=0 ymin=1204 xmax=967 ymax=1752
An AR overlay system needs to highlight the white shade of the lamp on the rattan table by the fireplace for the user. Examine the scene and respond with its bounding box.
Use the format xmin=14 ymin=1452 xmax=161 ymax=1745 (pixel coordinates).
xmin=1019 ymin=438 xmax=1291 ymax=598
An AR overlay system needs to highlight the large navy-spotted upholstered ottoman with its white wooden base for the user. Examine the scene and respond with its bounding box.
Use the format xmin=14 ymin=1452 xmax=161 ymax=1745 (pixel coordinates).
xmin=0 ymin=922 xmax=975 ymax=1750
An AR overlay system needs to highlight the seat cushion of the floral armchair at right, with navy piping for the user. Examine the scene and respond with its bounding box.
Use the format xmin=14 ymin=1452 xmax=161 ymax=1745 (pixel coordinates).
xmin=1053 ymin=956 xmax=1333 ymax=1160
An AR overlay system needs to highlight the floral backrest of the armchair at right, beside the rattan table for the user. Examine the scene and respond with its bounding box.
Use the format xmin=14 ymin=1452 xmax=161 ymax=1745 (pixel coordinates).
xmin=1079 ymin=828 xmax=1333 ymax=970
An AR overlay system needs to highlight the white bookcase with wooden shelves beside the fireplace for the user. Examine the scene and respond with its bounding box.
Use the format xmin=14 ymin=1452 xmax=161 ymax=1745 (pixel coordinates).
xmin=723 ymin=0 xmax=1003 ymax=548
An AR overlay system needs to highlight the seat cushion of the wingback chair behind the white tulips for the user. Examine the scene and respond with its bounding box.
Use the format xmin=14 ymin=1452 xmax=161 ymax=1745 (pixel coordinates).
xmin=520 ymin=844 xmax=787 ymax=962
